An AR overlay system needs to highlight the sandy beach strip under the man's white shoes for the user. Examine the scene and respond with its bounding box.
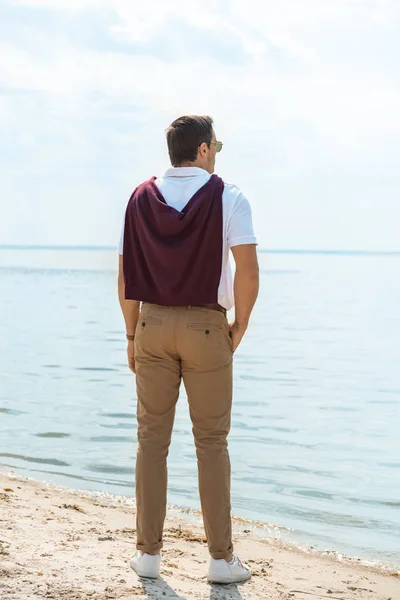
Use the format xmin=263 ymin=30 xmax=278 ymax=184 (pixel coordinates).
xmin=0 ymin=472 xmax=400 ymax=600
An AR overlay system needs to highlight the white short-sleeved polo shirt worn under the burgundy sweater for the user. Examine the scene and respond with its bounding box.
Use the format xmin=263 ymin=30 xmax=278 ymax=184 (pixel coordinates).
xmin=119 ymin=167 xmax=257 ymax=310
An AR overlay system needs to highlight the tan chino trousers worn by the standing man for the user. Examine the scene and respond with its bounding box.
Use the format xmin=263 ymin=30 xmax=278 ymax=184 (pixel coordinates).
xmin=135 ymin=304 xmax=232 ymax=559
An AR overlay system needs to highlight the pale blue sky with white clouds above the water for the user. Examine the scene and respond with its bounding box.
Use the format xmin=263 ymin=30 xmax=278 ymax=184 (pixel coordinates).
xmin=0 ymin=0 xmax=400 ymax=251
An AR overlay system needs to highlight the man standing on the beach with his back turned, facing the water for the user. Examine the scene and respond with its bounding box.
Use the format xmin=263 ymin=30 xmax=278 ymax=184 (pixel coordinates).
xmin=118 ymin=116 xmax=259 ymax=583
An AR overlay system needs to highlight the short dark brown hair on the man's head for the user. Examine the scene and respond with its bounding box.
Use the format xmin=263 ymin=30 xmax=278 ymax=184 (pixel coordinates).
xmin=167 ymin=115 xmax=213 ymax=167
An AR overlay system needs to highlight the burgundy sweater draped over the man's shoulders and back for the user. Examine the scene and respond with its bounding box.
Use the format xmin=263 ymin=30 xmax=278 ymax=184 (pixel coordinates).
xmin=123 ymin=175 xmax=224 ymax=306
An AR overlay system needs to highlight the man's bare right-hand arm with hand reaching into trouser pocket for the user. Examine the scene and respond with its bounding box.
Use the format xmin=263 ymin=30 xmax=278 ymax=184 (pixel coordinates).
xmin=231 ymin=244 xmax=259 ymax=352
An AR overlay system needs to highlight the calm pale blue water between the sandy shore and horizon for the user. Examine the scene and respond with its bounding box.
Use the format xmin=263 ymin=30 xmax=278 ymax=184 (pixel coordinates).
xmin=0 ymin=249 xmax=400 ymax=564
